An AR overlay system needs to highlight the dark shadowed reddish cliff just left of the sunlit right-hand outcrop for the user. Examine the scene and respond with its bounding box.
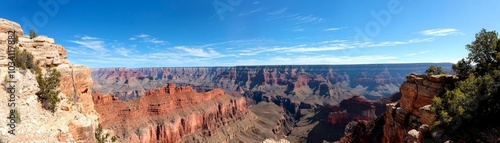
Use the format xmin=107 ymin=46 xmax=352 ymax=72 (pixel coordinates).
xmin=307 ymin=93 xmax=401 ymax=142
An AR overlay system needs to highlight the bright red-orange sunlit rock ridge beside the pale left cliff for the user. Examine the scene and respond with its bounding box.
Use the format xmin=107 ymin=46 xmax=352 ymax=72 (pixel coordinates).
xmin=93 ymin=83 xmax=248 ymax=142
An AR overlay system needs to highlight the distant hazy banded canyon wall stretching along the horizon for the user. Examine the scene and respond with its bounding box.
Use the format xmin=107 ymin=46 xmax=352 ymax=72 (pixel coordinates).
xmin=92 ymin=63 xmax=451 ymax=101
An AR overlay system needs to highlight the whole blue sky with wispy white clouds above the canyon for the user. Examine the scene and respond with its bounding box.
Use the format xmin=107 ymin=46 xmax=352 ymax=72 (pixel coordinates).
xmin=0 ymin=0 xmax=500 ymax=68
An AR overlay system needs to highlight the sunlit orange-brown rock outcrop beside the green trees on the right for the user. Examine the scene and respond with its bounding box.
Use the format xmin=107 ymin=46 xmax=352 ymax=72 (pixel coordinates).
xmin=382 ymin=74 xmax=458 ymax=143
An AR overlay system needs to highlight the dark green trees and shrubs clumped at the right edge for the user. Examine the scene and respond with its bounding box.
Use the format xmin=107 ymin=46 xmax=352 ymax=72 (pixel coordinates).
xmin=432 ymin=29 xmax=500 ymax=141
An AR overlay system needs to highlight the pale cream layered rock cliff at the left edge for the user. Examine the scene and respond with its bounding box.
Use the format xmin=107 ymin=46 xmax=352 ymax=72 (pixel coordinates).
xmin=0 ymin=18 xmax=98 ymax=142
